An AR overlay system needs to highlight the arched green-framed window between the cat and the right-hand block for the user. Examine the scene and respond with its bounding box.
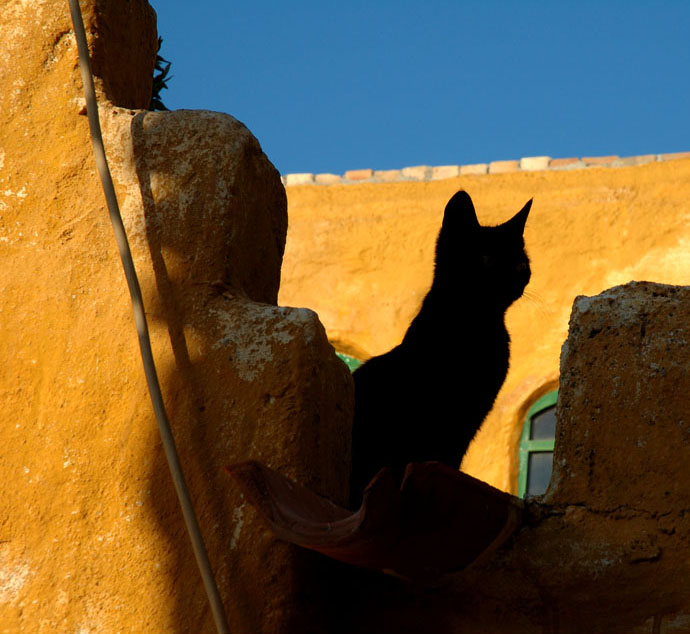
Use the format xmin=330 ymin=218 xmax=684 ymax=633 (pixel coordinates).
xmin=518 ymin=391 xmax=558 ymax=498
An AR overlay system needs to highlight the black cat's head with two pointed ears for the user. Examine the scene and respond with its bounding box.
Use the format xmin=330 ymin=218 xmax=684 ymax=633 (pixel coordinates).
xmin=434 ymin=190 xmax=532 ymax=308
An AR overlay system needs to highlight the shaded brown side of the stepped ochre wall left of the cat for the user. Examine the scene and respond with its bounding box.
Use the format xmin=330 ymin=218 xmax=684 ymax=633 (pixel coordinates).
xmin=123 ymin=111 xmax=352 ymax=634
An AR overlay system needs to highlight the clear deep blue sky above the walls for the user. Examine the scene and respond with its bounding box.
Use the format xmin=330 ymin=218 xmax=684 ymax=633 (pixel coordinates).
xmin=155 ymin=0 xmax=690 ymax=174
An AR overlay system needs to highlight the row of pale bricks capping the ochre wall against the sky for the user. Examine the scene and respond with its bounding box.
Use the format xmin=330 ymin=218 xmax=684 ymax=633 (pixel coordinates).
xmin=282 ymin=152 xmax=690 ymax=186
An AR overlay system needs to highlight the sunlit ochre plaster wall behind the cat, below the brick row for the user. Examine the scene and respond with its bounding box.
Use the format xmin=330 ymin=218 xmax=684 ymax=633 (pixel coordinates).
xmin=279 ymin=159 xmax=690 ymax=493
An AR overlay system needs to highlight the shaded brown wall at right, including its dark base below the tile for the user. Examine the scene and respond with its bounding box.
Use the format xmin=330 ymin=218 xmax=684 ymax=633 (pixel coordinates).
xmin=304 ymin=283 xmax=690 ymax=634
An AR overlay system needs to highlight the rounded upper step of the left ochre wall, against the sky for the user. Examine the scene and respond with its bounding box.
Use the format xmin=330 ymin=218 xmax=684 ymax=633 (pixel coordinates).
xmin=101 ymin=107 xmax=287 ymax=303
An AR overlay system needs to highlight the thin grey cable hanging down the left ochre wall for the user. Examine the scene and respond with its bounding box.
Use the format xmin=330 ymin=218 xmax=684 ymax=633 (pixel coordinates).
xmin=68 ymin=0 xmax=230 ymax=634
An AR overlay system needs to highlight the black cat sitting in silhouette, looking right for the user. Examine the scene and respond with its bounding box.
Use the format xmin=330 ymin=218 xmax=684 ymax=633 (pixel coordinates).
xmin=350 ymin=191 xmax=532 ymax=508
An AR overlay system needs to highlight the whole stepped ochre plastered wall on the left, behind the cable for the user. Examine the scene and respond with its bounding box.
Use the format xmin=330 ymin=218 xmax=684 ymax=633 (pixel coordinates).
xmin=0 ymin=0 xmax=352 ymax=634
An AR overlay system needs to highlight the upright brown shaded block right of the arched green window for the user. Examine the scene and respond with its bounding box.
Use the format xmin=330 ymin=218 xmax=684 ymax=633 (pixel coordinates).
xmin=549 ymin=282 xmax=690 ymax=514
